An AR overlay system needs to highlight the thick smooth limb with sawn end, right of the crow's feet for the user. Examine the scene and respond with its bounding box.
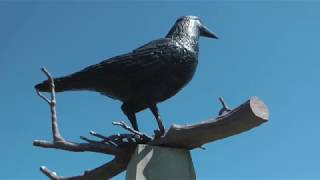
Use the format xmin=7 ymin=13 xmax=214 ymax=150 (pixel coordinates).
xmin=149 ymin=97 xmax=269 ymax=149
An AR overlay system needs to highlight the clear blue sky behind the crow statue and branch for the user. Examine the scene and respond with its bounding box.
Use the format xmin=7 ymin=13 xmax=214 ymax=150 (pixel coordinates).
xmin=0 ymin=1 xmax=320 ymax=179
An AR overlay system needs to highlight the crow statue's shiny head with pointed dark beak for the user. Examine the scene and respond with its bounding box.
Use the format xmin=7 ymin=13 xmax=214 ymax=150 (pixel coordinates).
xmin=167 ymin=16 xmax=218 ymax=39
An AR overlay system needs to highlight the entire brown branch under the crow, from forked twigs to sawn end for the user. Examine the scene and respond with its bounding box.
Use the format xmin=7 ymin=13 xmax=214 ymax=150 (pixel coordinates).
xmin=33 ymin=68 xmax=269 ymax=180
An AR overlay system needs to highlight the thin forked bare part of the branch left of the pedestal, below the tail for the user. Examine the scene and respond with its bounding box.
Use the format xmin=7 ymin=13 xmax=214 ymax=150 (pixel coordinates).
xmin=33 ymin=68 xmax=135 ymax=180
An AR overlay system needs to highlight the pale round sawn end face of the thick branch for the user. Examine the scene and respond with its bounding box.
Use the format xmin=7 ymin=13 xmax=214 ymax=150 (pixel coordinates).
xmin=249 ymin=96 xmax=269 ymax=121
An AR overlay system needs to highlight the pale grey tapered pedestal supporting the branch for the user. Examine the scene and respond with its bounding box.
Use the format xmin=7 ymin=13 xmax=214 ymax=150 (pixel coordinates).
xmin=126 ymin=144 xmax=196 ymax=180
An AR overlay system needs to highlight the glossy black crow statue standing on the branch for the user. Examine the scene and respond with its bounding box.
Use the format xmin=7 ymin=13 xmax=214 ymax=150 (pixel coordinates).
xmin=35 ymin=16 xmax=217 ymax=135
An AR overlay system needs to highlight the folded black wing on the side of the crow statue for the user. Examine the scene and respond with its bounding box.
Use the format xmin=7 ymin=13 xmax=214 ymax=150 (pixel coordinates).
xmin=80 ymin=38 xmax=177 ymax=80
